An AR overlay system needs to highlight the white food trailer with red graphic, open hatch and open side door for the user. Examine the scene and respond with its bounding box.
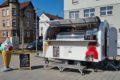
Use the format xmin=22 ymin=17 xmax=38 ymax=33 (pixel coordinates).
xmin=43 ymin=17 xmax=117 ymax=73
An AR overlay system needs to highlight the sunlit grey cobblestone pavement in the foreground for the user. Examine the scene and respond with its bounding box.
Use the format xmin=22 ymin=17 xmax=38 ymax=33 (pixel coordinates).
xmin=0 ymin=54 xmax=120 ymax=80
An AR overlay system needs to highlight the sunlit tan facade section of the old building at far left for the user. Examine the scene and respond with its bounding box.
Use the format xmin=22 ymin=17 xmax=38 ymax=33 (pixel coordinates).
xmin=0 ymin=0 xmax=19 ymax=43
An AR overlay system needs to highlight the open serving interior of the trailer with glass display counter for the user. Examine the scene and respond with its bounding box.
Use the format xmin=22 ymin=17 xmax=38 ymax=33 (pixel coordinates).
xmin=46 ymin=20 xmax=99 ymax=40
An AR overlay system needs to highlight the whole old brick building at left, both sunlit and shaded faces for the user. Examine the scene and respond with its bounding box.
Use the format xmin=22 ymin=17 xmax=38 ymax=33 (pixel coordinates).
xmin=0 ymin=0 xmax=36 ymax=43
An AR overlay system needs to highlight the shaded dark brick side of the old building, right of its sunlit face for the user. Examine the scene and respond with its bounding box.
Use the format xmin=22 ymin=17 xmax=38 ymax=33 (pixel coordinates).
xmin=19 ymin=2 xmax=36 ymax=43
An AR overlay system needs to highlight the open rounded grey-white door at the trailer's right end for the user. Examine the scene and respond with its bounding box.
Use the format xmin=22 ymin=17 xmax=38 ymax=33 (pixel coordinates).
xmin=108 ymin=27 xmax=117 ymax=57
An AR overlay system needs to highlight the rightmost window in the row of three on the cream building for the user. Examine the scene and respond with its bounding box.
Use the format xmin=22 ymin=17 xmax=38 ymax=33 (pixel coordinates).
xmin=100 ymin=6 xmax=113 ymax=16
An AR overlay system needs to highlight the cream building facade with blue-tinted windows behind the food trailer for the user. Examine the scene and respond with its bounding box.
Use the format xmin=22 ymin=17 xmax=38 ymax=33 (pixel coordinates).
xmin=64 ymin=0 xmax=120 ymax=52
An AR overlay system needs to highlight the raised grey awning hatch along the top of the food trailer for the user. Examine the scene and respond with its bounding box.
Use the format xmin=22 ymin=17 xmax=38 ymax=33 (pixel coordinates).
xmin=48 ymin=17 xmax=101 ymax=27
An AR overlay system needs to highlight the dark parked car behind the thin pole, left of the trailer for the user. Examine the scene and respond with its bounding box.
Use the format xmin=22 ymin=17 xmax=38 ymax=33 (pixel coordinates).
xmin=26 ymin=39 xmax=43 ymax=50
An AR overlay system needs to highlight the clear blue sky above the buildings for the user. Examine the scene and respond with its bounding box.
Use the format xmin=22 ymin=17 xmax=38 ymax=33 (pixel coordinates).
xmin=0 ymin=0 xmax=64 ymax=17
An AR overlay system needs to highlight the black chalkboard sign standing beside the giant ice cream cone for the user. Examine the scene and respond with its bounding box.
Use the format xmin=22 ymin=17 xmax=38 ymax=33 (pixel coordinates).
xmin=19 ymin=54 xmax=31 ymax=68
